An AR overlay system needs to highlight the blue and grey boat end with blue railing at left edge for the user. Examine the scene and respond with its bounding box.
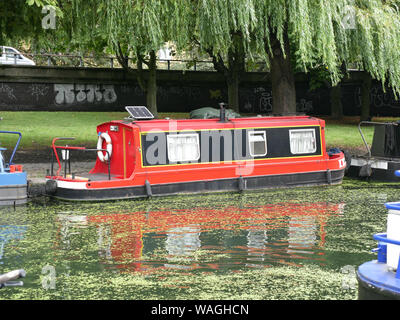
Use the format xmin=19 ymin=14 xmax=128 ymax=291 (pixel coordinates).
xmin=0 ymin=131 xmax=28 ymax=205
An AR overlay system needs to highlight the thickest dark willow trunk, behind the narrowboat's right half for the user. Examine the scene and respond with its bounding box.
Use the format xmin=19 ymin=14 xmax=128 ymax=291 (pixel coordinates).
xmin=267 ymin=32 xmax=296 ymax=114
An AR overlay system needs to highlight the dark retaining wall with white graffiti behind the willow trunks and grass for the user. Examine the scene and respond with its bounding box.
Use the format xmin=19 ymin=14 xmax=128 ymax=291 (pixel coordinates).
xmin=0 ymin=66 xmax=400 ymax=115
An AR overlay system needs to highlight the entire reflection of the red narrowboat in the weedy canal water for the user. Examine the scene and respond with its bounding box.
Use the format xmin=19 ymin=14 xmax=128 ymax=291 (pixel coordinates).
xmin=55 ymin=202 xmax=344 ymax=271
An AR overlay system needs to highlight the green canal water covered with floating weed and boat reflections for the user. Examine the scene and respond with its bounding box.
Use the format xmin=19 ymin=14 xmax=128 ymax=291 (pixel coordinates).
xmin=0 ymin=179 xmax=400 ymax=300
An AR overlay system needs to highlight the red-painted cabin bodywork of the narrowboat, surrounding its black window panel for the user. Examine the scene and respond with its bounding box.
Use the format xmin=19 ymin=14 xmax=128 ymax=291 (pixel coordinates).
xmin=90 ymin=116 xmax=328 ymax=187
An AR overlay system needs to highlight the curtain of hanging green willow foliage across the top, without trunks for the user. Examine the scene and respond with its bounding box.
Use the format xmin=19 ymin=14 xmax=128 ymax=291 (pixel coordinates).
xmin=65 ymin=0 xmax=400 ymax=94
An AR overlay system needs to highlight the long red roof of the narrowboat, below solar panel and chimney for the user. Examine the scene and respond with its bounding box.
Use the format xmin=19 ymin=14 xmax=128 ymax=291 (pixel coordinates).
xmin=102 ymin=116 xmax=325 ymax=132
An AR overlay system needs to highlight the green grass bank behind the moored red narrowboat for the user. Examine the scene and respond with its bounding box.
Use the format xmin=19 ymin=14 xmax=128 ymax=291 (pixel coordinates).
xmin=0 ymin=112 xmax=397 ymax=152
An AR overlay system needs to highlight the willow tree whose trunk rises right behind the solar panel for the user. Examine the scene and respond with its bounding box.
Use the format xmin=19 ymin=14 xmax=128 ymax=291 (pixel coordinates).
xmin=72 ymin=0 xmax=186 ymax=117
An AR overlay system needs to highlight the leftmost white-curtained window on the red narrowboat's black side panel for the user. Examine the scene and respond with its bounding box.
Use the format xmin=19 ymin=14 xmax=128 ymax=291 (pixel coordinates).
xmin=167 ymin=133 xmax=200 ymax=162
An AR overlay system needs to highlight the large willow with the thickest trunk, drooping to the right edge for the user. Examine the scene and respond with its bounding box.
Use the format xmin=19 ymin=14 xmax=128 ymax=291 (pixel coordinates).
xmin=253 ymin=0 xmax=400 ymax=113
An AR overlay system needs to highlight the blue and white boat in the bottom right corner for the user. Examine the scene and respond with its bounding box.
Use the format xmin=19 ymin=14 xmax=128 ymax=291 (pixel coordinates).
xmin=357 ymin=174 xmax=400 ymax=300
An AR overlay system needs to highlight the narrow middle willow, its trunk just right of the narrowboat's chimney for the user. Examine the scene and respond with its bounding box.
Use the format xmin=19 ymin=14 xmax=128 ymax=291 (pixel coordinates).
xmin=187 ymin=0 xmax=256 ymax=111
